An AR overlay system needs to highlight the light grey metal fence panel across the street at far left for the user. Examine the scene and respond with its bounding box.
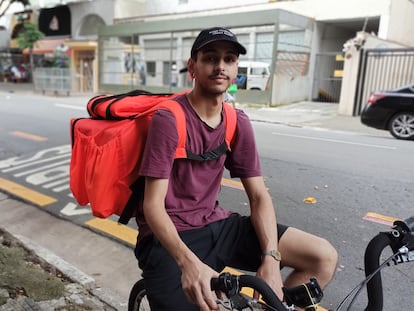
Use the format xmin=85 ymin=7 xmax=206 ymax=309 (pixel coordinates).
xmin=33 ymin=68 xmax=72 ymax=96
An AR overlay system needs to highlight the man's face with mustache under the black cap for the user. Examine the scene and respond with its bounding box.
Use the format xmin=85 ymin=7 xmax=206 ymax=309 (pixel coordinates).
xmin=189 ymin=41 xmax=238 ymax=95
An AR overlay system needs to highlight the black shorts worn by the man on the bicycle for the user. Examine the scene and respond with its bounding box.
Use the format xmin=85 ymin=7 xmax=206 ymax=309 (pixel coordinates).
xmin=135 ymin=214 xmax=288 ymax=310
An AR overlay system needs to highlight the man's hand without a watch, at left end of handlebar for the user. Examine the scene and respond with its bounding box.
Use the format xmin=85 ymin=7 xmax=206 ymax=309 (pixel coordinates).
xmin=181 ymin=260 xmax=219 ymax=311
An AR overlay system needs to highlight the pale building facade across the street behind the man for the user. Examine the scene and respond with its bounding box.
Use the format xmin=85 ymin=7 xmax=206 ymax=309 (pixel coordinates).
xmin=0 ymin=0 xmax=414 ymax=111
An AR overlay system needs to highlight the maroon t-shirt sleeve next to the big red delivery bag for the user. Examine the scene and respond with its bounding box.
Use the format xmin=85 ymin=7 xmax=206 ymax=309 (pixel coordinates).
xmin=139 ymin=109 xmax=178 ymax=178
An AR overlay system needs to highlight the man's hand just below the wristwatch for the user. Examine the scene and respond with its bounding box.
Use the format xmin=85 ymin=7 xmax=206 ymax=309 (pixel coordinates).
xmin=254 ymin=256 xmax=283 ymax=301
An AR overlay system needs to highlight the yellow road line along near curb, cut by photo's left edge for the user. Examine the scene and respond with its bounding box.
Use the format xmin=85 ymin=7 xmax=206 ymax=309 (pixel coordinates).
xmin=0 ymin=178 xmax=57 ymax=206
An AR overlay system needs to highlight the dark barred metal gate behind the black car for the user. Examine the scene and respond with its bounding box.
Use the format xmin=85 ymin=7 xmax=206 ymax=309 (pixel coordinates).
xmin=353 ymin=49 xmax=414 ymax=116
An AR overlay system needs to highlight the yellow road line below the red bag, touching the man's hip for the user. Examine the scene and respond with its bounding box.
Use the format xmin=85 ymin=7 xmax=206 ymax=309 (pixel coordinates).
xmin=85 ymin=218 xmax=138 ymax=245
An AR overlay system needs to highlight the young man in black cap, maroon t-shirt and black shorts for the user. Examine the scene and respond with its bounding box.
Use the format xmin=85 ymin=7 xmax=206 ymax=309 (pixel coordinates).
xmin=136 ymin=28 xmax=337 ymax=311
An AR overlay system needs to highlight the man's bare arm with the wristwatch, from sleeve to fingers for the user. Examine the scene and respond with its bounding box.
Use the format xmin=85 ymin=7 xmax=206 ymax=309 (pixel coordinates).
xmin=241 ymin=176 xmax=283 ymax=299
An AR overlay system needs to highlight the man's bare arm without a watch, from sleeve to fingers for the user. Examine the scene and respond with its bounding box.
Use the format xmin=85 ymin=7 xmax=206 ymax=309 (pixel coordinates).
xmin=143 ymin=177 xmax=218 ymax=310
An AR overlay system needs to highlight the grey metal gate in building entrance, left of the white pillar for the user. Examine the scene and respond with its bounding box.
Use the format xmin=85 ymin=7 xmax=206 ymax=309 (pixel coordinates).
xmin=312 ymin=52 xmax=344 ymax=103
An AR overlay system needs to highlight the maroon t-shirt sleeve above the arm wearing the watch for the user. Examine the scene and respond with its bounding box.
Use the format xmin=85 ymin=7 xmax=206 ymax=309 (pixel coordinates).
xmin=225 ymin=110 xmax=262 ymax=178
